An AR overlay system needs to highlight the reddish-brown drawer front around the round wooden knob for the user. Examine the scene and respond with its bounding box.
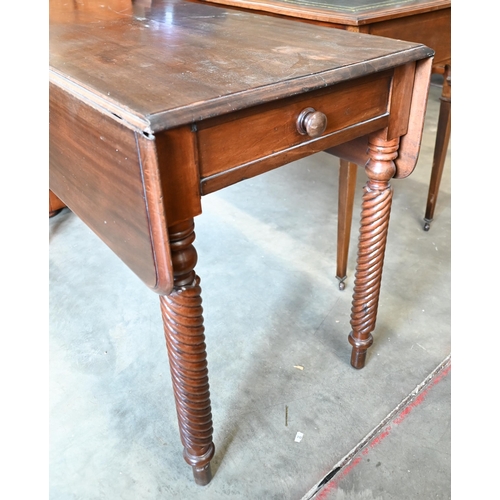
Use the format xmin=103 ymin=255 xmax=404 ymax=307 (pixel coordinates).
xmin=197 ymin=72 xmax=392 ymax=180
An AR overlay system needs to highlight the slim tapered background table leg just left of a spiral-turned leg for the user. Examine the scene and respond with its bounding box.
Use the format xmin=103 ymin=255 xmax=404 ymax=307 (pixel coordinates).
xmin=337 ymin=158 xmax=358 ymax=290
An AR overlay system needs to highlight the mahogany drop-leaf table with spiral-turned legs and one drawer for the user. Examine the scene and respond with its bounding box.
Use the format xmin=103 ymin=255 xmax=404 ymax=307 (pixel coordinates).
xmin=49 ymin=0 xmax=433 ymax=485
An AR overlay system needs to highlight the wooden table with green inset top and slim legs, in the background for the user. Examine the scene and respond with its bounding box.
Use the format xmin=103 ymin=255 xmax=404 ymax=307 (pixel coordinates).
xmin=201 ymin=0 xmax=451 ymax=290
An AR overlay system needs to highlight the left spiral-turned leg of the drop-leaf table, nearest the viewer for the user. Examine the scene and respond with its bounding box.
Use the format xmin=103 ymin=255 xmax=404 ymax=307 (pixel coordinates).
xmin=160 ymin=219 xmax=215 ymax=485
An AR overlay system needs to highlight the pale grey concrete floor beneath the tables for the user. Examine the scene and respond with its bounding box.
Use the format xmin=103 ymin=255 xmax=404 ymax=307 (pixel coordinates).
xmin=49 ymin=80 xmax=451 ymax=500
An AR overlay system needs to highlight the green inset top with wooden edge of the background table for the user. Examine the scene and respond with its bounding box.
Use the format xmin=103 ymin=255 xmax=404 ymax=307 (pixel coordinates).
xmin=202 ymin=0 xmax=451 ymax=26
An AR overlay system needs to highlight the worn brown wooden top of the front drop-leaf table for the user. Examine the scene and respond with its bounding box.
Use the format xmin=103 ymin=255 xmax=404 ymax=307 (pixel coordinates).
xmin=50 ymin=0 xmax=437 ymax=132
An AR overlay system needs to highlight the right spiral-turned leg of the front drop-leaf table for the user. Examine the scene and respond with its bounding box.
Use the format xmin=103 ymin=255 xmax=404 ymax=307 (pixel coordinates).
xmin=349 ymin=136 xmax=399 ymax=369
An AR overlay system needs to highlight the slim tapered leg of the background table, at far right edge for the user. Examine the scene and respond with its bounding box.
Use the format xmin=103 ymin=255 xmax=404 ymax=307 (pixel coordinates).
xmin=424 ymin=66 xmax=451 ymax=231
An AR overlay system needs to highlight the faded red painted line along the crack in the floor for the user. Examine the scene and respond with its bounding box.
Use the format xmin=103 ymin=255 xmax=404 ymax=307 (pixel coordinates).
xmin=316 ymin=364 xmax=451 ymax=500
